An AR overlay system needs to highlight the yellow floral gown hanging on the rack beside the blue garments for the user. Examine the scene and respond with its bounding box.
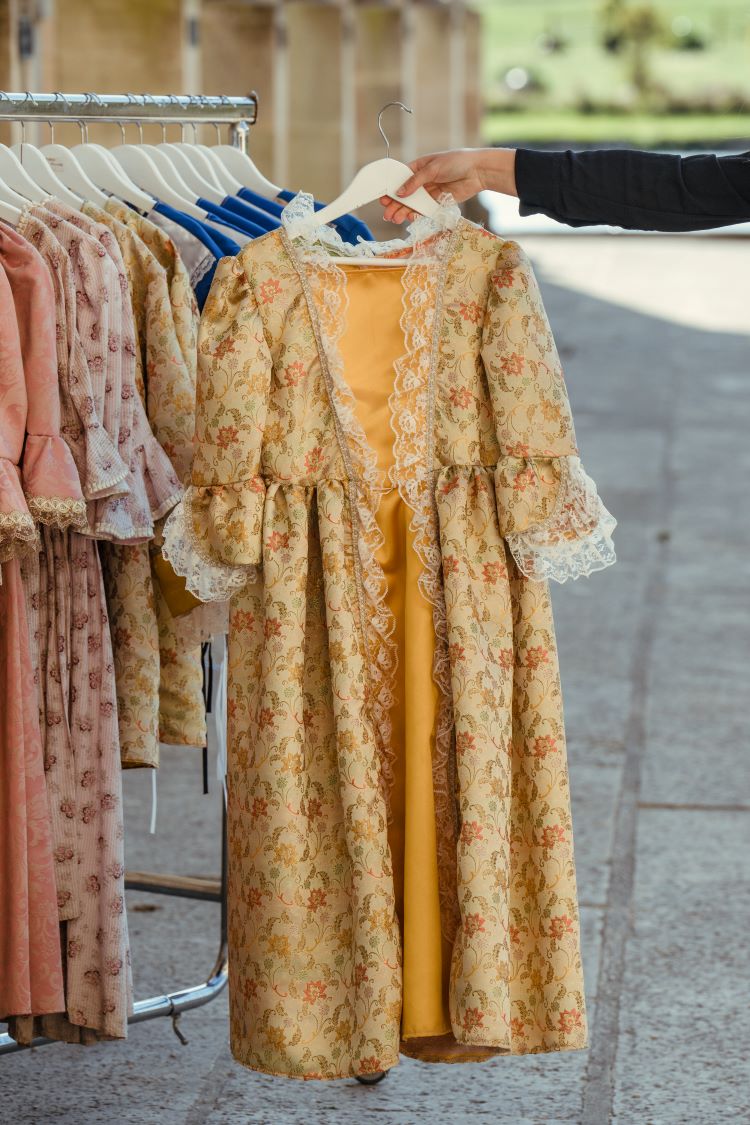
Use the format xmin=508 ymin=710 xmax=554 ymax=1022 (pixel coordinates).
xmin=83 ymin=198 xmax=206 ymax=768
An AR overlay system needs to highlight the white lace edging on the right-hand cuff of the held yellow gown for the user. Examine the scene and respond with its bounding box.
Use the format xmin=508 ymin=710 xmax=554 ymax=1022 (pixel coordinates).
xmin=506 ymin=457 xmax=617 ymax=583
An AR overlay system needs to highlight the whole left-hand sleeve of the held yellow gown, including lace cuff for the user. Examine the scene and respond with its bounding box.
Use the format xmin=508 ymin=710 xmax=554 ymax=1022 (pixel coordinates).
xmin=163 ymin=258 xmax=272 ymax=602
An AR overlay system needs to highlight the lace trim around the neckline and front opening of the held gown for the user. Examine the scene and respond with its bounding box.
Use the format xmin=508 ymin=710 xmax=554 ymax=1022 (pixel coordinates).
xmin=282 ymin=192 xmax=461 ymax=941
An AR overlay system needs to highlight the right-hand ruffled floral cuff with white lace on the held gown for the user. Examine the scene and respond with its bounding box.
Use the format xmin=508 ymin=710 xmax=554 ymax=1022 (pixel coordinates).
xmin=495 ymin=457 xmax=617 ymax=582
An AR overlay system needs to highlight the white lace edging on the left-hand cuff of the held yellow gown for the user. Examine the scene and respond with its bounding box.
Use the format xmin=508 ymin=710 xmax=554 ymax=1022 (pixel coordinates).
xmin=162 ymin=494 xmax=260 ymax=602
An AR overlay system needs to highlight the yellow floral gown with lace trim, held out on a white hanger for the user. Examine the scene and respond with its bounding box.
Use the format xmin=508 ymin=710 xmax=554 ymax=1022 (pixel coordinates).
xmin=164 ymin=192 xmax=614 ymax=1079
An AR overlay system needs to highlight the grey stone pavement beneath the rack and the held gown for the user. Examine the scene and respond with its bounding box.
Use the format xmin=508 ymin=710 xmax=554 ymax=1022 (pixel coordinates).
xmin=0 ymin=235 xmax=750 ymax=1125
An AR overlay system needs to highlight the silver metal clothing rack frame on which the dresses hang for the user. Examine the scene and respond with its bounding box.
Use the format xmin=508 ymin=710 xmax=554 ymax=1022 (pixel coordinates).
xmin=0 ymin=91 xmax=251 ymax=1054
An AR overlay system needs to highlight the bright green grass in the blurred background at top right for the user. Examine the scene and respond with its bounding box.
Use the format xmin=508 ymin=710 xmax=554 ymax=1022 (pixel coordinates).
xmin=475 ymin=0 xmax=750 ymax=146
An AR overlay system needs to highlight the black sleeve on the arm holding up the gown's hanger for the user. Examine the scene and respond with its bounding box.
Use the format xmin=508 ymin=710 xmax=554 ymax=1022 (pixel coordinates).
xmin=515 ymin=149 xmax=750 ymax=231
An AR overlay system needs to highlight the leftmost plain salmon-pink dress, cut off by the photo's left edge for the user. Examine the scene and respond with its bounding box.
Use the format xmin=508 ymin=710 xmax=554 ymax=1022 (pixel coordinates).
xmin=0 ymin=253 xmax=64 ymax=1019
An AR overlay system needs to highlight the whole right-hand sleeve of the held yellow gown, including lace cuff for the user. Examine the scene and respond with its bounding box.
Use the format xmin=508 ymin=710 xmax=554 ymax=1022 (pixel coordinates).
xmin=481 ymin=241 xmax=616 ymax=582
